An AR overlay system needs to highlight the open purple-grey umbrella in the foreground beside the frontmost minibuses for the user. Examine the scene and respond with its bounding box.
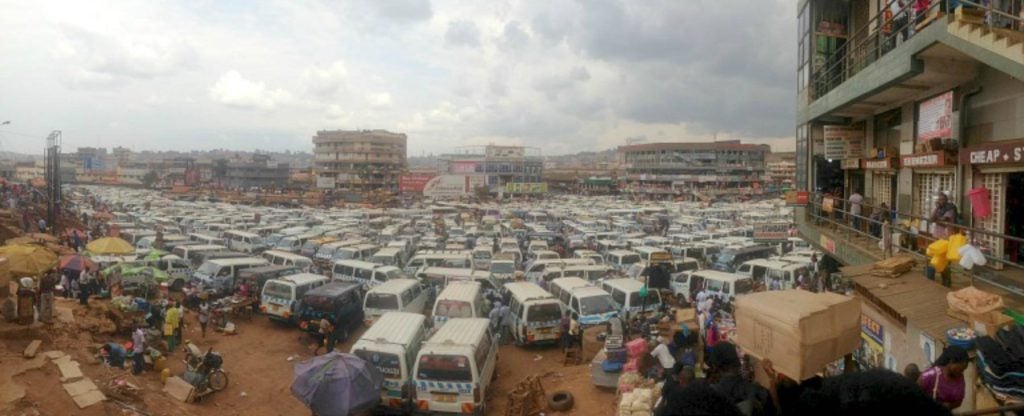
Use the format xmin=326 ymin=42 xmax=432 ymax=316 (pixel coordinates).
xmin=292 ymin=351 xmax=384 ymax=416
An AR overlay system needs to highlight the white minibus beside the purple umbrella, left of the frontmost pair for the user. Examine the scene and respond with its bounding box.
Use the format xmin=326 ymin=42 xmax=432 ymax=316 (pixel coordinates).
xmin=351 ymin=311 xmax=427 ymax=414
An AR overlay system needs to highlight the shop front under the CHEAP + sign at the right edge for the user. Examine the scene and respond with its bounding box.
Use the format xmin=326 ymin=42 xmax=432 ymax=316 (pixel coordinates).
xmin=959 ymin=139 xmax=1024 ymax=267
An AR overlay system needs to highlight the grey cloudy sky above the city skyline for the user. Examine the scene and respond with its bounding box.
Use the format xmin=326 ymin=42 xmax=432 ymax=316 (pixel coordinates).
xmin=0 ymin=0 xmax=797 ymax=156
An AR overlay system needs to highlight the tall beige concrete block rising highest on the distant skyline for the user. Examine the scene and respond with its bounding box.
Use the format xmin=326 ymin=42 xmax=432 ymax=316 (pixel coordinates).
xmin=312 ymin=130 xmax=407 ymax=195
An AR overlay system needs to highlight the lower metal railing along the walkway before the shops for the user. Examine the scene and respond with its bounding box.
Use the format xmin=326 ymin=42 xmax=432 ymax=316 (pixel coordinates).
xmin=806 ymin=194 xmax=1024 ymax=296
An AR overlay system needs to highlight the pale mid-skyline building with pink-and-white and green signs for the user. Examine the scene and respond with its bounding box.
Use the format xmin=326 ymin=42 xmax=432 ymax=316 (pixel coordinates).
xmin=439 ymin=144 xmax=546 ymax=194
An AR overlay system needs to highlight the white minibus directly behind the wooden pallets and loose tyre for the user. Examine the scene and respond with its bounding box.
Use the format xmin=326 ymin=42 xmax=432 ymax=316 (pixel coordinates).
xmin=505 ymin=282 xmax=562 ymax=345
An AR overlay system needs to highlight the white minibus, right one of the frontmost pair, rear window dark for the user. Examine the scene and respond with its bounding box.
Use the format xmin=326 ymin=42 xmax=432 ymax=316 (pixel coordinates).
xmin=413 ymin=318 xmax=498 ymax=415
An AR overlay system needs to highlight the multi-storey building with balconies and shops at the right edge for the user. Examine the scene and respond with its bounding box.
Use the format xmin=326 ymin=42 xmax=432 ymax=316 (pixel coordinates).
xmin=795 ymin=0 xmax=1024 ymax=377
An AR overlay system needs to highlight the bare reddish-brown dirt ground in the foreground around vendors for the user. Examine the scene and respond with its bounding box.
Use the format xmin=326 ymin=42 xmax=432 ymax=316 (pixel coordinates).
xmin=0 ymin=300 xmax=615 ymax=416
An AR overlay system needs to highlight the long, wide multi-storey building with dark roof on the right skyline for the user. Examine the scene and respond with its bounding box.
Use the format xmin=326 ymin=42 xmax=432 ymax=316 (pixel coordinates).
xmin=618 ymin=140 xmax=771 ymax=196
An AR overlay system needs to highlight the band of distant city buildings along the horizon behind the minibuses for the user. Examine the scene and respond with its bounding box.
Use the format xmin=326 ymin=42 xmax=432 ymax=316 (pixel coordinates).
xmin=0 ymin=130 xmax=796 ymax=202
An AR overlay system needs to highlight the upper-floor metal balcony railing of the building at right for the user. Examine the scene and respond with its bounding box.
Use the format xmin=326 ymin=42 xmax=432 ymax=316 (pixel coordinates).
xmin=807 ymin=0 xmax=1024 ymax=99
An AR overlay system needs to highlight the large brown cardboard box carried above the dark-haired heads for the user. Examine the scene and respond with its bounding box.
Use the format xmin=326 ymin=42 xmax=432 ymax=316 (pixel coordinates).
xmin=734 ymin=290 xmax=860 ymax=380
